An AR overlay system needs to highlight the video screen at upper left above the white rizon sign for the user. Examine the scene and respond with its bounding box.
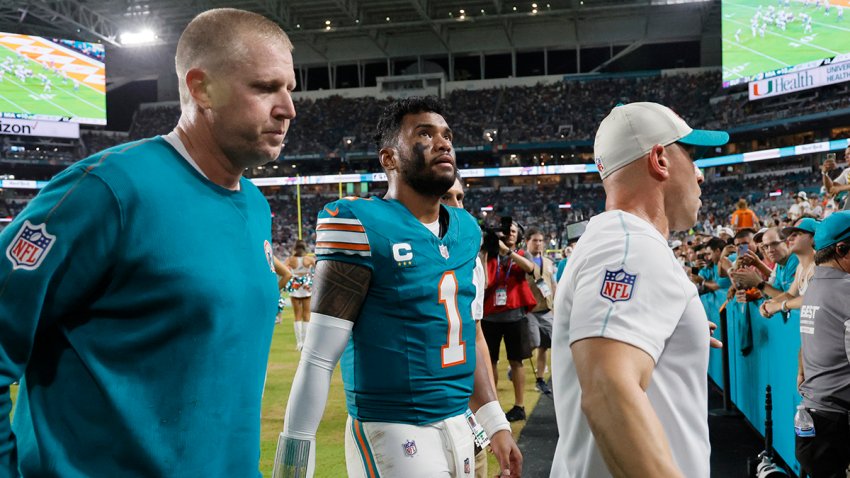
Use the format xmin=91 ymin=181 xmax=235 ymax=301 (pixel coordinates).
xmin=0 ymin=33 xmax=106 ymax=125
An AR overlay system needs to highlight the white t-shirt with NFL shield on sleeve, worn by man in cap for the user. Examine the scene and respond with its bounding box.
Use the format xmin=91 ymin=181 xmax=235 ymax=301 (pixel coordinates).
xmin=551 ymin=210 xmax=711 ymax=478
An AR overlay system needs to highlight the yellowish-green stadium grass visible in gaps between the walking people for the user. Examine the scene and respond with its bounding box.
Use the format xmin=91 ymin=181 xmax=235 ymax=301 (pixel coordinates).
xmin=11 ymin=307 xmax=536 ymax=477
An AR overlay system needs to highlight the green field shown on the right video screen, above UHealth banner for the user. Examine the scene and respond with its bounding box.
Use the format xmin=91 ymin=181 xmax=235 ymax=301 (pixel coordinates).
xmin=722 ymin=0 xmax=850 ymax=81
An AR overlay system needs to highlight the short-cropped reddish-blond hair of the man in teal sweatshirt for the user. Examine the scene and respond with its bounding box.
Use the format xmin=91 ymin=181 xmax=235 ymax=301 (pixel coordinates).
xmin=174 ymin=8 xmax=292 ymax=106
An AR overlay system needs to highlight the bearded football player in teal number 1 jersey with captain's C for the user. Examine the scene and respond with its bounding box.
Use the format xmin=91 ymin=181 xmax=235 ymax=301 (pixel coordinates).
xmin=274 ymin=98 xmax=522 ymax=478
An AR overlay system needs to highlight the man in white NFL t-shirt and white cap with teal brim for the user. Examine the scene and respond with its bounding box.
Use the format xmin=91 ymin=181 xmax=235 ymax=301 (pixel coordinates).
xmin=551 ymin=103 xmax=729 ymax=478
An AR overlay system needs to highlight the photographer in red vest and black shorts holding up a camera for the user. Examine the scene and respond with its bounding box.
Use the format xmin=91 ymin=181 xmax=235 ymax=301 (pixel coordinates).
xmin=481 ymin=217 xmax=537 ymax=422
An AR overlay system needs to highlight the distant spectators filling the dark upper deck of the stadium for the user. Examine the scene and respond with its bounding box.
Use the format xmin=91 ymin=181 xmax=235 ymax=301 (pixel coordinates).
xmin=119 ymin=71 xmax=850 ymax=157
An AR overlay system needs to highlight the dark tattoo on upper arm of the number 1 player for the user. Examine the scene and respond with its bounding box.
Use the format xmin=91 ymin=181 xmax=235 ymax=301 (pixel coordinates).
xmin=311 ymin=261 xmax=372 ymax=322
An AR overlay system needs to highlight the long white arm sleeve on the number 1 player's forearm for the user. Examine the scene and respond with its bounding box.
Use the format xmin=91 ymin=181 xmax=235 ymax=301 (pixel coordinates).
xmin=283 ymin=312 xmax=354 ymax=440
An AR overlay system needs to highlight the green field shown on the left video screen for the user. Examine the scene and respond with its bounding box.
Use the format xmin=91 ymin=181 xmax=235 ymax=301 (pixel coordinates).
xmin=0 ymin=46 xmax=106 ymax=121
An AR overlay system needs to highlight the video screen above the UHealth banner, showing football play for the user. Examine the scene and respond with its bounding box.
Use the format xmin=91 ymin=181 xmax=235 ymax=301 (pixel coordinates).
xmin=721 ymin=0 xmax=850 ymax=87
